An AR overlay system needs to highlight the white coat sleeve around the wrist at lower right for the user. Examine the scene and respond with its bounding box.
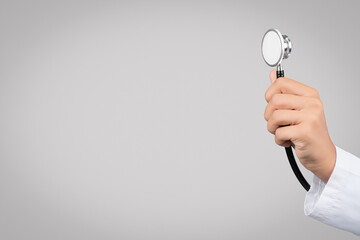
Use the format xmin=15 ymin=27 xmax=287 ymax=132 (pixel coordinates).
xmin=304 ymin=147 xmax=360 ymax=235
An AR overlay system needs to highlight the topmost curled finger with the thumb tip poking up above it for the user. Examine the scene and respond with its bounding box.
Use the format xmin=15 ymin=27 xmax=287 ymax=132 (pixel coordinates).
xmin=265 ymin=74 xmax=319 ymax=102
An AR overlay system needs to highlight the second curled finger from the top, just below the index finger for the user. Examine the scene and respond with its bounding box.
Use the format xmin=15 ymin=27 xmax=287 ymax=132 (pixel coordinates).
xmin=264 ymin=94 xmax=316 ymax=120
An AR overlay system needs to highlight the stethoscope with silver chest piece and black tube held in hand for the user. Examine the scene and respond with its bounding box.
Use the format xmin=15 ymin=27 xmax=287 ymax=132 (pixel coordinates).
xmin=261 ymin=29 xmax=310 ymax=191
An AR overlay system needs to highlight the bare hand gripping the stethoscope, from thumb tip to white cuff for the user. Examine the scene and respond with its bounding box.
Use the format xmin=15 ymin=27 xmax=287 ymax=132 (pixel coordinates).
xmin=264 ymin=70 xmax=336 ymax=183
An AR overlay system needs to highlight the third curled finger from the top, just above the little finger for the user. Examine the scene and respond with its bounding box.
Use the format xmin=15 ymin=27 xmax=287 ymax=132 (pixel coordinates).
xmin=267 ymin=110 xmax=305 ymax=134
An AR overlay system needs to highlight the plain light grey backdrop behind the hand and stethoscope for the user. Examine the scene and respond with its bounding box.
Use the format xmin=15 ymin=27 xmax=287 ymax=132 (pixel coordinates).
xmin=0 ymin=0 xmax=360 ymax=240
